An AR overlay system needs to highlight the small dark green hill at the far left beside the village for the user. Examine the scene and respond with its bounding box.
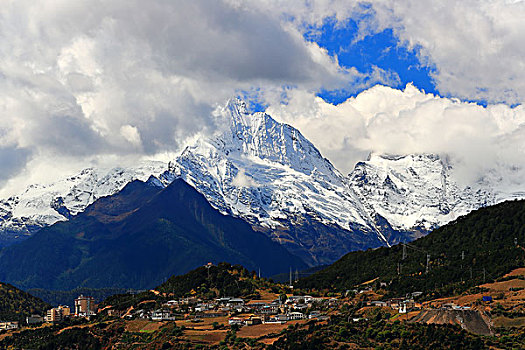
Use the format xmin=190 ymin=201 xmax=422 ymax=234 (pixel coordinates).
xmin=0 ymin=283 xmax=51 ymax=321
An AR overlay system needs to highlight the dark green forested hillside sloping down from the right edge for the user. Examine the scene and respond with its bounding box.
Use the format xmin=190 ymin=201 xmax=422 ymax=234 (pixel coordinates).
xmin=298 ymin=201 xmax=525 ymax=294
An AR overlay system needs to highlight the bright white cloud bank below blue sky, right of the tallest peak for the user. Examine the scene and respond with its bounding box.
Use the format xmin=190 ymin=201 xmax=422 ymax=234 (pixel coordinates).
xmin=268 ymin=85 xmax=525 ymax=182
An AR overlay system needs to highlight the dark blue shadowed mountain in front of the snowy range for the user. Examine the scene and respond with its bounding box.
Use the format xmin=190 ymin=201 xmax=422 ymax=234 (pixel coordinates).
xmin=0 ymin=178 xmax=306 ymax=289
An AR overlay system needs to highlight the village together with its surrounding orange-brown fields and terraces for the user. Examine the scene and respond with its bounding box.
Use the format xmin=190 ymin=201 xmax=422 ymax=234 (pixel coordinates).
xmin=0 ymin=265 xmax=525 ymax=345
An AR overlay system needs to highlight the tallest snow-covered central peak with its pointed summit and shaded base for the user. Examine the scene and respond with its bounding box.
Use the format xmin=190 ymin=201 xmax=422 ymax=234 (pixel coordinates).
xmin=161 ymin=100 xmax=396 ymax=265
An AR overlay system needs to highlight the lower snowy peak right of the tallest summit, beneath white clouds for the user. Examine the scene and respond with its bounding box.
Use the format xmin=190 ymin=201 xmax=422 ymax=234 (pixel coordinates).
xmin=349 ymin=154 xmax=496 ymax=233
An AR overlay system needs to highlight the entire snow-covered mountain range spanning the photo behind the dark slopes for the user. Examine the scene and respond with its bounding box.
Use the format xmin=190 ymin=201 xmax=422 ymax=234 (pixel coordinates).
xmin=0 ymin=99 xmax=524 ymax=265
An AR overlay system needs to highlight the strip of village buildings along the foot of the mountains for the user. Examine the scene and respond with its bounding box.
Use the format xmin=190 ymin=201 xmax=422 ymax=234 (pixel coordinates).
xmin=0 ymin=286 xmax=492 ymax=330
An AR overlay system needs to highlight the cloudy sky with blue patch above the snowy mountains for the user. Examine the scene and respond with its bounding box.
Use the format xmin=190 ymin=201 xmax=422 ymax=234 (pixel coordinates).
xmin=0 ymin=0 xmax=525 ymax=190
